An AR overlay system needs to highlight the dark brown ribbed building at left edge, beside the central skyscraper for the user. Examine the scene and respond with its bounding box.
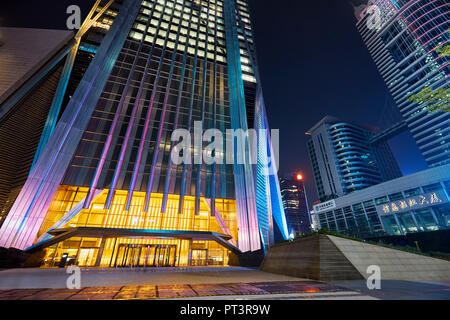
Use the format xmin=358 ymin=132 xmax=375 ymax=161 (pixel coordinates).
xmin=0 ymin=28 xmax=73 ymax=226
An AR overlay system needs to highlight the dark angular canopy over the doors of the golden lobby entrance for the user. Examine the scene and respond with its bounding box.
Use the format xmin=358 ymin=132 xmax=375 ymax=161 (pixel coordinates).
xmin=26 ymin=227 xmax=240 ymax=253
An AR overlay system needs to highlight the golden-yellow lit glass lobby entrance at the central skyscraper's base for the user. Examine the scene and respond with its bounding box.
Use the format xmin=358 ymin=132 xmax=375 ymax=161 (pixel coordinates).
xmin=28 ymin=186 xmax=238 ymax=268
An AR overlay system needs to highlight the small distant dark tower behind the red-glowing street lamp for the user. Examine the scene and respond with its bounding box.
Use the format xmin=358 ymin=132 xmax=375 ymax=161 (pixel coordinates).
xmin=280 ymin=173 xmax=311 ymax=238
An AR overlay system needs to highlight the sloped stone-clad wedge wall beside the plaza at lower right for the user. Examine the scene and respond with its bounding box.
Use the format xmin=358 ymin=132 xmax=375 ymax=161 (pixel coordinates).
xmin=261 ymin=235 xmax=450 ymax=281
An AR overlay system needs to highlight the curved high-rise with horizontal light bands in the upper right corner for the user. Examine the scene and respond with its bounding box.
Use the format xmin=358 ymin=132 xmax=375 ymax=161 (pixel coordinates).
xmin=355 ymin=0 xmax=450 ymax=167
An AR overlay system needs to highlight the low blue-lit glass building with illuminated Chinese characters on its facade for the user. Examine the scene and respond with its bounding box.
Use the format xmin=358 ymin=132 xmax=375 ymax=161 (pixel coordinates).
xmin=313 ymin=165 xmax=450 ymax=238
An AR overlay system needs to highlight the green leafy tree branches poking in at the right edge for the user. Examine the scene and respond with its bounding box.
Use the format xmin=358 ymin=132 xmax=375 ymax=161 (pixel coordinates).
xmin=409 ymin=29 xmax=450 ymax=112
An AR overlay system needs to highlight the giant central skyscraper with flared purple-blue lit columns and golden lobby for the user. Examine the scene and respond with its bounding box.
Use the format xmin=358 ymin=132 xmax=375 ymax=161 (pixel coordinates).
xmin=0 ymin=0 xmax=288 ymax=267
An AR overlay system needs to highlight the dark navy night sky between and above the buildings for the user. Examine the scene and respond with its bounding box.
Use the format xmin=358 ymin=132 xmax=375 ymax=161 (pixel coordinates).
xmin=0 ymin=0 xmax=426 ymax=202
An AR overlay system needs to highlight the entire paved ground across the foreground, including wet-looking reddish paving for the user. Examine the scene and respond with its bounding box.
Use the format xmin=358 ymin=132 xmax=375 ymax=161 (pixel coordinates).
xmin=0 ymin=267 xmax=450 ymax=300
